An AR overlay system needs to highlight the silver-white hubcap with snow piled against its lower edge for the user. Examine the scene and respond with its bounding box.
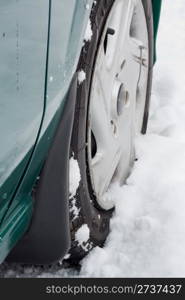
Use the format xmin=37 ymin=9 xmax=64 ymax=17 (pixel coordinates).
xmin=87 ymin=0 xmax=149 ymax=209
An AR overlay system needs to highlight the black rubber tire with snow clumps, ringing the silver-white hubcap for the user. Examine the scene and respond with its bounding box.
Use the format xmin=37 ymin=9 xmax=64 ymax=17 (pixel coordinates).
xmin=66 ymin=0 xmax=154 ymax=264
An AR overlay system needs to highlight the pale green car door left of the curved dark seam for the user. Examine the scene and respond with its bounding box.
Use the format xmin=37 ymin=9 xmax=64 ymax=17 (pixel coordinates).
xmin=0 ymin=0 xmax=50 ymax=221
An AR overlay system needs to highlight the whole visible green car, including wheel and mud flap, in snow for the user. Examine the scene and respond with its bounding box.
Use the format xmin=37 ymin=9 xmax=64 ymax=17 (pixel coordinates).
xmin=0 ymin=0 xmax=161 ymax=265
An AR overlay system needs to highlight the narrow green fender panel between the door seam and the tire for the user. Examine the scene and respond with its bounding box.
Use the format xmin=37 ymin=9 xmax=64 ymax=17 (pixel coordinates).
xmin=1 ymin=0 xmax=93 ymax=225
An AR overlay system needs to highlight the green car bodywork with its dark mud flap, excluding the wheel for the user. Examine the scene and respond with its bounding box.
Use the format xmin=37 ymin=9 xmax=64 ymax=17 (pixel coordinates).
xmin=0 ymin=0 xmax=161 ymax=263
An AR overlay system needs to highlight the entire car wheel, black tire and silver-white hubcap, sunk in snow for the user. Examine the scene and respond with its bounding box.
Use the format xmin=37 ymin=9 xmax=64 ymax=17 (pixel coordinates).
xmin=68 ymin=0 xmax=153 ymax=263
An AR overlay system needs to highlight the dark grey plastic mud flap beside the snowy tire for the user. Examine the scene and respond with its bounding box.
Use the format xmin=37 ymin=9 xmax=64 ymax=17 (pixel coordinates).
xmin=7 ymin=74 xmax=77 ymax=264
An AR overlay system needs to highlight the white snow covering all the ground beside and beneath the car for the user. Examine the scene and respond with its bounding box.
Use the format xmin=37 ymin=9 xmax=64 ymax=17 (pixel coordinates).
xmin=0 ymin=0 xmax=185 ymax=277
